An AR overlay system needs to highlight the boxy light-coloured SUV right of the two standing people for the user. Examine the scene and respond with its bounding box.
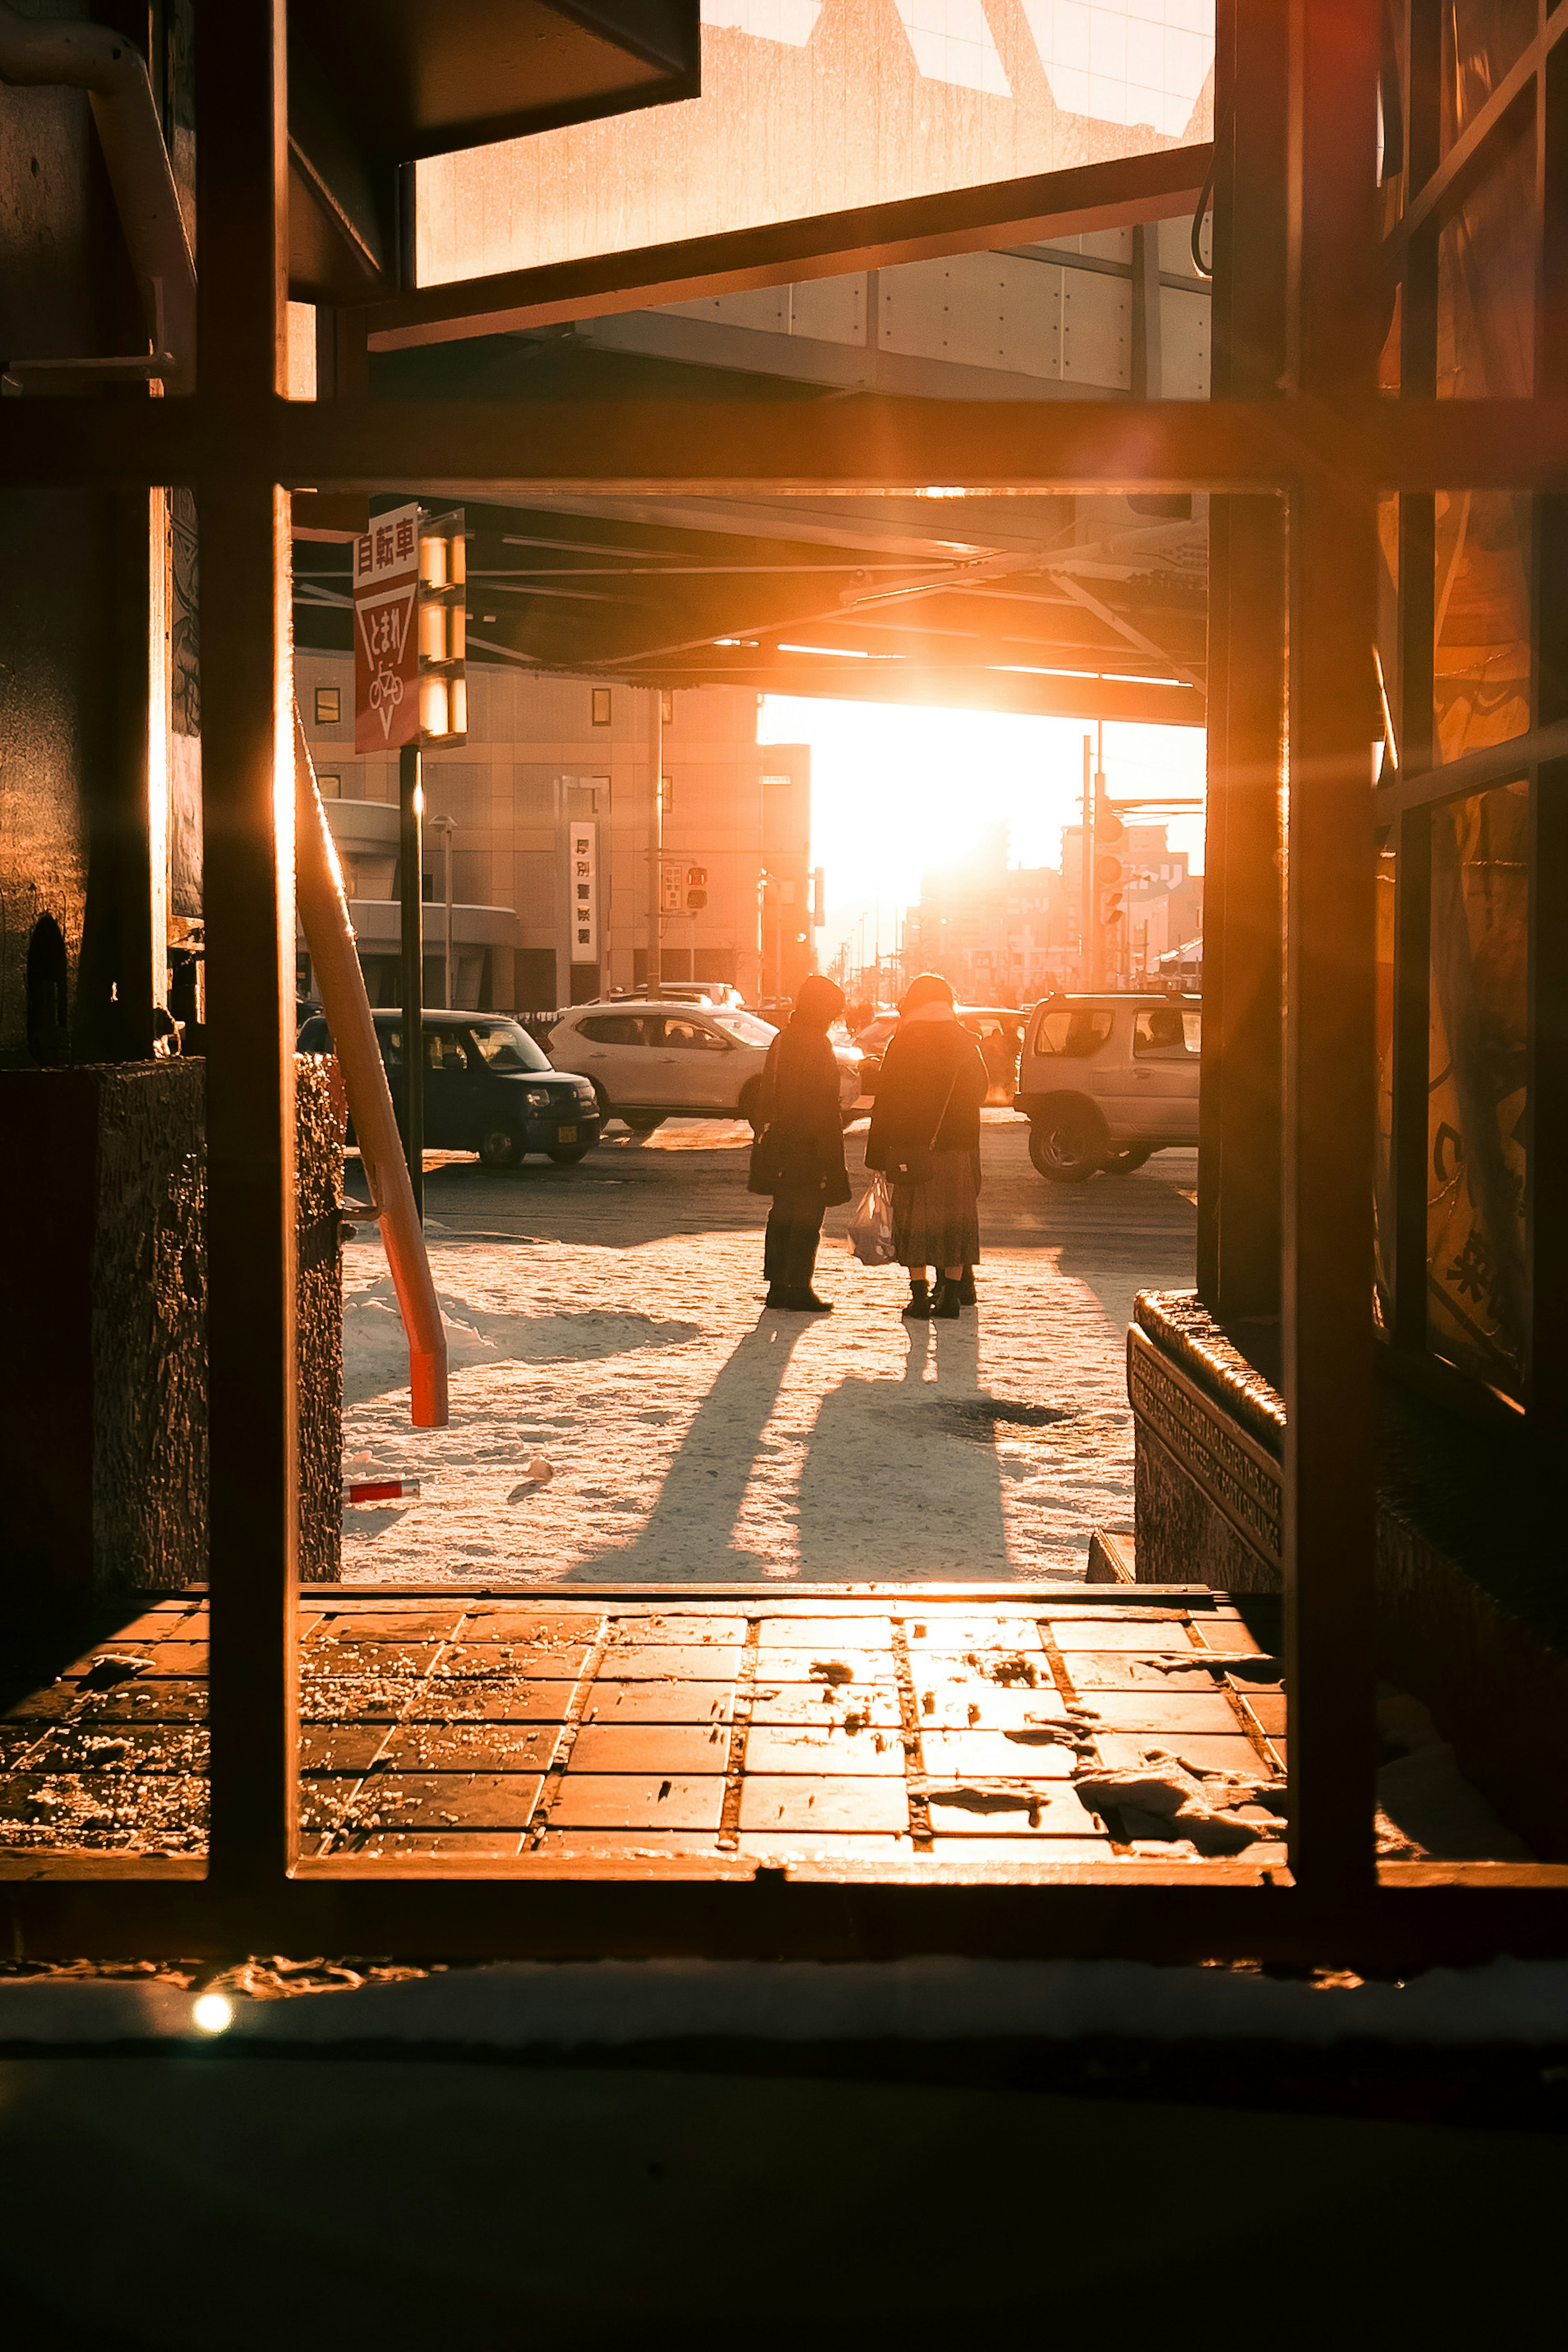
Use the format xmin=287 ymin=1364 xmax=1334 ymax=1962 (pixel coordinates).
xmin=1013 ymin=995 xmax=1204 ymax=1183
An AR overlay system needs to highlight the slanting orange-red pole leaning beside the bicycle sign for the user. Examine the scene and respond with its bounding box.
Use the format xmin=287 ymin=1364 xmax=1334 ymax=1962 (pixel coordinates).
xmin=294 ymin=710 xmax=447 ymax=1430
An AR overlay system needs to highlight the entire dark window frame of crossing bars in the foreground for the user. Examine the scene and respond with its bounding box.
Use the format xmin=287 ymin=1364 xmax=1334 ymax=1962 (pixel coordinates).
xmin=0 ymin=0 xmax=1568 ymax=1962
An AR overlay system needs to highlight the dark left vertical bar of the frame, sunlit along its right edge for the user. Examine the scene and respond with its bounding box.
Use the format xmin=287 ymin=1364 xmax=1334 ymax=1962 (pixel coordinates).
xmin=197 ymin=0 xmax=298 ymax=1900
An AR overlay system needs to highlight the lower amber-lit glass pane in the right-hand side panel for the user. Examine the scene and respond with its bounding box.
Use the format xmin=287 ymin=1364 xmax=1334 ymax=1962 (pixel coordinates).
xmin=1427 ymin=783 xmax=1530 ymax=1395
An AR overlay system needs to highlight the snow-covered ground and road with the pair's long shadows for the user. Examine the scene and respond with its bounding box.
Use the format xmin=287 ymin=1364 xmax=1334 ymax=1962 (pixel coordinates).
xmin=343 ymin=1112 xmax=1196 ymax=1585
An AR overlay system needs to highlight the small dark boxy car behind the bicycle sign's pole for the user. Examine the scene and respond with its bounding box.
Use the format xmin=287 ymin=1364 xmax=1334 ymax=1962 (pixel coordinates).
xmin=298 ymin=1011 xmax=602 ymax=1169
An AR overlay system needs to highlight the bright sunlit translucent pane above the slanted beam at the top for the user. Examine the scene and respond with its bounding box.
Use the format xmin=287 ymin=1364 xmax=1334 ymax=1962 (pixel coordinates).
xmin=416 ymin=0 xmax=1213 ymax=285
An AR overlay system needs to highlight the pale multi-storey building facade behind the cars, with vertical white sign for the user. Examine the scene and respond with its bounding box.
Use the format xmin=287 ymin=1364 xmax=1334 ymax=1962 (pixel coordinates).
xmin=296 ymin=649 xmax=811 ymax=1011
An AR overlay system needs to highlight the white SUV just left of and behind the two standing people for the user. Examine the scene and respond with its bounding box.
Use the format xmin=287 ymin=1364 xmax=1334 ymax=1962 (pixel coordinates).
xmin=550 ymin=997 xmax=860 ymax=1136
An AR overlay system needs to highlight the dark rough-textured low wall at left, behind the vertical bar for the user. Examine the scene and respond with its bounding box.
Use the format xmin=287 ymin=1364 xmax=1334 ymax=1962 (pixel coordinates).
xmin=0 ymin=1056 xmax=343 ymax=1621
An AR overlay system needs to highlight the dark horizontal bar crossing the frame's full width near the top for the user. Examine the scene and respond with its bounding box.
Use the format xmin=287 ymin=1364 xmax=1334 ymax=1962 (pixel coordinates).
xmin=15 ymin=393 xmax=1568 ymax=496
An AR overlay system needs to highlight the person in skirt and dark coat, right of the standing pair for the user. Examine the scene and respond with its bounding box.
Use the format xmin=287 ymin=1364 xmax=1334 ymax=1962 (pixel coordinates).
xmin=865 ymin=971 xmax=990 ymax=1319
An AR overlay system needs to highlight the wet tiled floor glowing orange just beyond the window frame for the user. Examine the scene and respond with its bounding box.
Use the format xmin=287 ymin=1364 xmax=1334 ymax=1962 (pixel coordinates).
xmin=0 ymin=1585 xmax=1283 ymax=1877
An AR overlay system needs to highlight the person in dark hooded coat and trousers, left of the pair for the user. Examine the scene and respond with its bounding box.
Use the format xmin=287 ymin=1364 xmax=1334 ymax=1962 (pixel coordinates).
xmin=750 ymin=971 xmax=849 ymax=1315
